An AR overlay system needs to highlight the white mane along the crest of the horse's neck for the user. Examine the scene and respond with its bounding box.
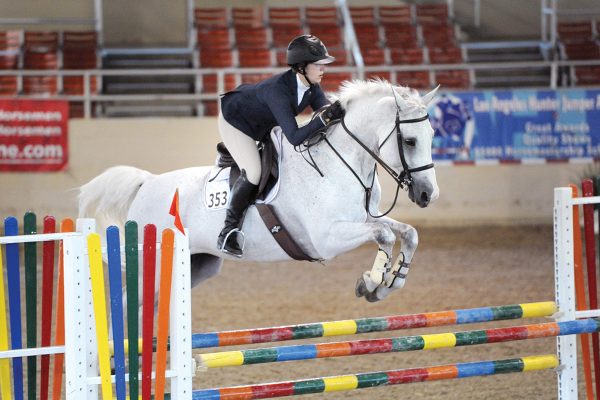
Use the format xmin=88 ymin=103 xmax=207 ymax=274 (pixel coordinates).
xmin=337 ymin=79 xmax=423 ymax=108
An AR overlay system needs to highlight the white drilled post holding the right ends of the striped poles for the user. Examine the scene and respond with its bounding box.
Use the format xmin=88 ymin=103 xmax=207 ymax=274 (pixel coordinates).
xmin=554 ymin=188 xmax=577 ymax=400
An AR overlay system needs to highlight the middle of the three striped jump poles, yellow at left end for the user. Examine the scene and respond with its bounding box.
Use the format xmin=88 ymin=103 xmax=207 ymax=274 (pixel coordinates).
xmin=198 ymin=318 xmax=600 ymax=368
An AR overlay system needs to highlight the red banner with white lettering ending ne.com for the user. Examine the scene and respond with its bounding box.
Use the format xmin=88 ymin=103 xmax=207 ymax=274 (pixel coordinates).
xmin=0 ymin=100 xmax=69 ymax=172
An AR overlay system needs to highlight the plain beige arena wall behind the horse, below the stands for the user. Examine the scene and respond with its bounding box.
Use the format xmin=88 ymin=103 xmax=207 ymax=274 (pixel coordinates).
xmin=0 ymin=118 xmax=590 ymax=226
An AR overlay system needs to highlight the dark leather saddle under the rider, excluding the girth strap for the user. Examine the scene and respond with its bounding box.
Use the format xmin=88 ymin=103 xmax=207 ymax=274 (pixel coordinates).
xmin=217 ymin=138 xmax=279 ymax=200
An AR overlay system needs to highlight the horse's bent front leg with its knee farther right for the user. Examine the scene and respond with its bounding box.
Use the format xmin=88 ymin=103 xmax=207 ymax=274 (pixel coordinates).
xmin=367 ymin=217 xmax=419 ymax=300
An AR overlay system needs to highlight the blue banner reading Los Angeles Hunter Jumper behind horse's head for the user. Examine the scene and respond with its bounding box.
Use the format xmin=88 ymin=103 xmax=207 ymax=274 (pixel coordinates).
xmin=429 ymin=89 xmax=600 ymax=161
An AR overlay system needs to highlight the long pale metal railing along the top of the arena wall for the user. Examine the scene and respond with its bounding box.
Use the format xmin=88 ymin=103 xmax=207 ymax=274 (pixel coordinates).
xmin=0 ymin=60 xmax=600 ymax=118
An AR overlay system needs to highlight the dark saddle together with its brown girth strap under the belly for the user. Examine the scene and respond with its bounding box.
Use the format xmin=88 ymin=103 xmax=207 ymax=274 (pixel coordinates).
xmin=213 ymin=137 xmax=322 ymax=262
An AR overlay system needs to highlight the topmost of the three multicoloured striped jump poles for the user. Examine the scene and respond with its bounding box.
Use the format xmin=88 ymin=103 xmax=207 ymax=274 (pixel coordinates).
xmin=192 ymin=301 xmax=557 ymax=349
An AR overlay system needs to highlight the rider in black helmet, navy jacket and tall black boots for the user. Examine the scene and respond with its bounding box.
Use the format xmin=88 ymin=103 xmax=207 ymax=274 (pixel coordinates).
xmin=217 ymin=35 xmax=344 ymax=257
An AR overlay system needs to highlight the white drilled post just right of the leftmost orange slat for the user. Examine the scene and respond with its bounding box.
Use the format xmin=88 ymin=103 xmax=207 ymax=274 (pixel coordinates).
xmin=63 ymin=235 xmax=88 ymax=400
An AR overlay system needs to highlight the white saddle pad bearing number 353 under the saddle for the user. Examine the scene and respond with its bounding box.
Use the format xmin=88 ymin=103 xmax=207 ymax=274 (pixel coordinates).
xmin=204 ymin=126 xmax=283 ymax=210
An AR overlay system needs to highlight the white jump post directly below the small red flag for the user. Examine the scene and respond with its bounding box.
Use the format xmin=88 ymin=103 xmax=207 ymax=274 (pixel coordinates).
xmin=170 ymin=231 xmax=192 ymax=400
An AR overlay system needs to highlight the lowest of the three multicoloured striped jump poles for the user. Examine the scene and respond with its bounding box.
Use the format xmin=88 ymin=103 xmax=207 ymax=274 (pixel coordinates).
xmin=192 ymin=355 xmax=558 ymax=400
